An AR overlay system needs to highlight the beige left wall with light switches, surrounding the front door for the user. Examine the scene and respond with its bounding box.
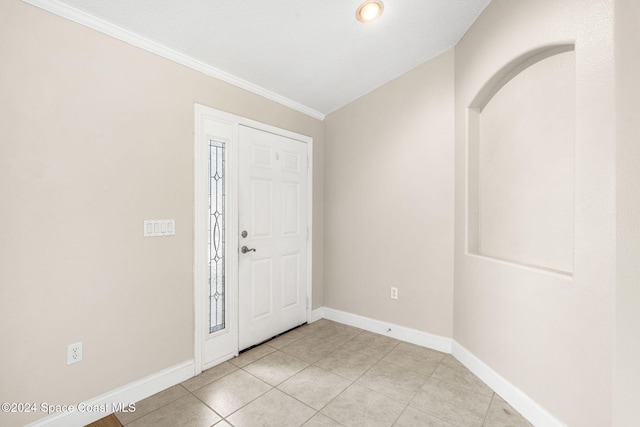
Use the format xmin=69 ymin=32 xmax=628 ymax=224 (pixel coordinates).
xmin=0 ymin=0 xmax=323 ymax=426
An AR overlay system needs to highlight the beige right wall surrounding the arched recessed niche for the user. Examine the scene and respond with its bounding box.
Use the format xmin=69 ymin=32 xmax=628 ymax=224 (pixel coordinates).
xmin=454 ymin=0 xmax=616 ymax=427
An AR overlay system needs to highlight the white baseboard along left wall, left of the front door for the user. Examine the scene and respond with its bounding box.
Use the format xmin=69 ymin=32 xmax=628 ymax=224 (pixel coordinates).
xmin=27 ymin=360 xmax=195 ymax=427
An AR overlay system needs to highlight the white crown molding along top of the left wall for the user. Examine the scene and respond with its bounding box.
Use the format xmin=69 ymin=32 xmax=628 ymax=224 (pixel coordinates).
xmin=22 ymin=0 xmax=326 ymax=121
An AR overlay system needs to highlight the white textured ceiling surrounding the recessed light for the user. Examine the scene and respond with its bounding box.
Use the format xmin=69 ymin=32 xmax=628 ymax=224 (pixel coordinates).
xmin=26 ymin=0 xmax=490 ymax=116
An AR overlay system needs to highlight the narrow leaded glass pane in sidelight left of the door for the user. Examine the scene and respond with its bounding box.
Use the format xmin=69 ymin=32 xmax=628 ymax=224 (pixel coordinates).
xmin=209 ymin=140 xmax=225 ymax=333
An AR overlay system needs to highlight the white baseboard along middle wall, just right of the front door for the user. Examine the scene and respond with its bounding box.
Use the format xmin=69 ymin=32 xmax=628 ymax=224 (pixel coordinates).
xmin=314 ymin=307 xmax=452 ymax=353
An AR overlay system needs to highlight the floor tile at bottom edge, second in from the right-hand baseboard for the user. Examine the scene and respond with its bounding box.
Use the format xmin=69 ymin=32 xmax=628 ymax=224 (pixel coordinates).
xmin=411 ymin=378 xmax=491 ymax=427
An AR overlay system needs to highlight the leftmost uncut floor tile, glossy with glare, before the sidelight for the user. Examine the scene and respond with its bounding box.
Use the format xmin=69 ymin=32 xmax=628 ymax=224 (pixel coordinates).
xmin=193 ymin=370 xmax=272 ymax=417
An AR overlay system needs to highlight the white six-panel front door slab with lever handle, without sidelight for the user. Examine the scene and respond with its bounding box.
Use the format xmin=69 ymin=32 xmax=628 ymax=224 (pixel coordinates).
xmin=238 ymin=125 xmax=308 ymax=350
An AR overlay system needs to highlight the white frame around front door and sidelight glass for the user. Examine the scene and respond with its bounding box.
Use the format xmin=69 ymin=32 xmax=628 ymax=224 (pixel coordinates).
xmin=193 ymin=104 xmax=313 ymax=375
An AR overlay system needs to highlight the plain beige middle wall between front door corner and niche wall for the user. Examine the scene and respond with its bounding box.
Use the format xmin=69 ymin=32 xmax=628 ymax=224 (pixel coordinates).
xmin=324 ymin=50 xmax=454 ymax=337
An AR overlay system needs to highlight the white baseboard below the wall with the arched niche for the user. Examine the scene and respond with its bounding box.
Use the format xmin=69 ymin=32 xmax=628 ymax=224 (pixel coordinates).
xmin=451 ymin=340 xmax=566 ymax=427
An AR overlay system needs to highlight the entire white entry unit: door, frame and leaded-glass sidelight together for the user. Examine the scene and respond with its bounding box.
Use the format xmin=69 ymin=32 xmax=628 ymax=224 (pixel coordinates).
xmin=194 ymin=105 xmax=313 ymax=375
